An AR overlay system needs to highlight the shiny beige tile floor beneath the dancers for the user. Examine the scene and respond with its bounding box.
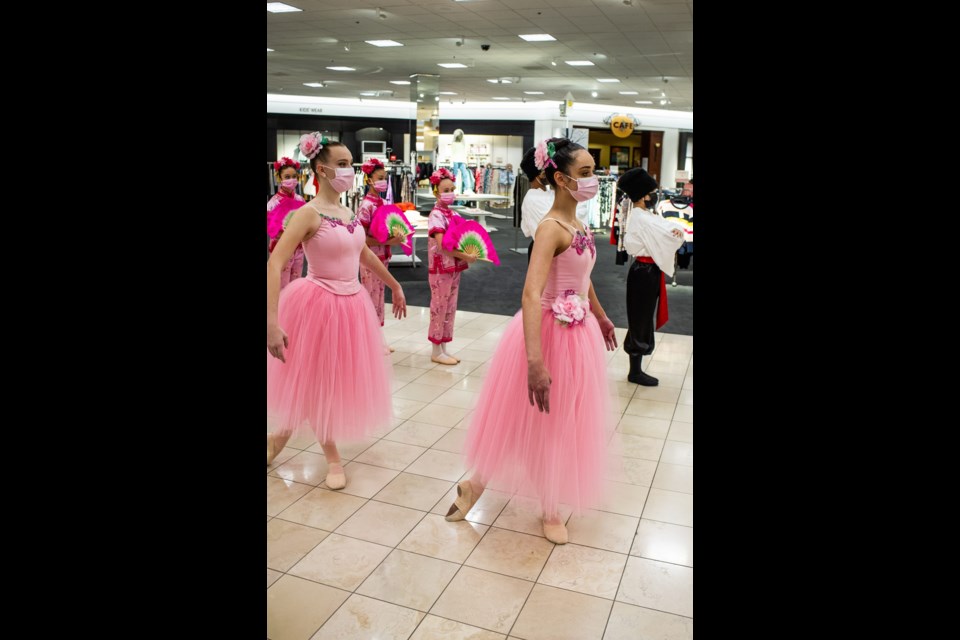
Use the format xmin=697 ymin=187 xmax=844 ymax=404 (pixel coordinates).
xmin=267 ymin=307 xmax=693 ymax=640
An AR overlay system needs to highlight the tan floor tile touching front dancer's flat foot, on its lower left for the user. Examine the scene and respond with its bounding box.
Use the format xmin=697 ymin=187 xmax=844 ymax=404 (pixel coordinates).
xmin=464 ymin=527 xmax=555 ymax=581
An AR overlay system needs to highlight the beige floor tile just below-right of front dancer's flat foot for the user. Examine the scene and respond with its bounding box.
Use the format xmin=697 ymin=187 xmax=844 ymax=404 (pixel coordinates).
xmin=537 ymin=544 xmax=627 ymax=600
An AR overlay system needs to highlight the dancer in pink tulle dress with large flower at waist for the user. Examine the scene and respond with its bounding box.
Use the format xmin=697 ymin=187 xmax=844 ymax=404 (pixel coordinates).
xmin=446 ymin=138 xmax=617 ymax=544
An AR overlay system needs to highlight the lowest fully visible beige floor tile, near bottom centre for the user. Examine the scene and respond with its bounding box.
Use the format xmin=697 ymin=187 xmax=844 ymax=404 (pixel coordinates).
xmin=430 ymin=567 xmax=534 ymax=633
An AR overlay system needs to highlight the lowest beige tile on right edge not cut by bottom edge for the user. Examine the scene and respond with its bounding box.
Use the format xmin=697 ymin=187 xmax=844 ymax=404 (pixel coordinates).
xmin=617 ymin=556 xmax=693 ymax=618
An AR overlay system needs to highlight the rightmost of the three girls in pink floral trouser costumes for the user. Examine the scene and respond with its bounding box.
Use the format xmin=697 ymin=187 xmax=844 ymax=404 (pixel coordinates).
xmin=427 ymin=169 xmax=477 ymax=364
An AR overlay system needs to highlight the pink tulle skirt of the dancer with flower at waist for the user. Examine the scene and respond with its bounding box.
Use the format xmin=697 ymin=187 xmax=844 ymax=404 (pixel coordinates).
xmin=464 ymin=310 xmax=614 ymax=512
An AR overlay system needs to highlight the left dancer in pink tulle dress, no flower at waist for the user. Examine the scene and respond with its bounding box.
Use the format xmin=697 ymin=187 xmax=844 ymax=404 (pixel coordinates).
xmin=267 ymin=132 xmax=406 ymax=489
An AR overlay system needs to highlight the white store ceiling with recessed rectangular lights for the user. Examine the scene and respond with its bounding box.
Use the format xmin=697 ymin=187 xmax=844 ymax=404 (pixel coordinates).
xmin=266 ymin=0 xmax=693 ymax=111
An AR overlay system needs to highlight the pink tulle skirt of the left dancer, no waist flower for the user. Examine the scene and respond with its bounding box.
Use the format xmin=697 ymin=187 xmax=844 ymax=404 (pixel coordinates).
xmin=267 ymin=278 xmax=393 ymax=442
